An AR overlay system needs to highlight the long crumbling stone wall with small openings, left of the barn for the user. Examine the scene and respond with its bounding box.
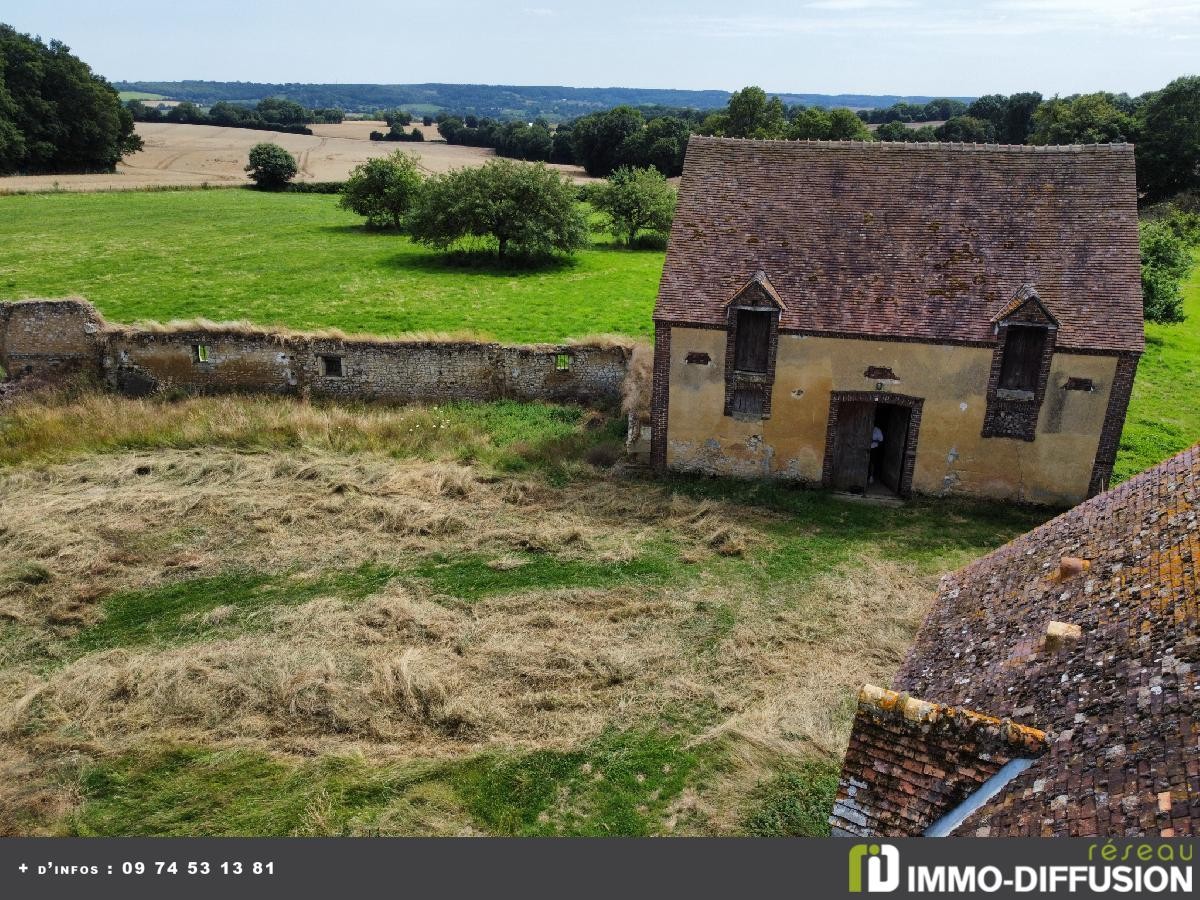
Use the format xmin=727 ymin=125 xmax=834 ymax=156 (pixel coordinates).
xmin=0 ymin=300 xmax=630 ymax=404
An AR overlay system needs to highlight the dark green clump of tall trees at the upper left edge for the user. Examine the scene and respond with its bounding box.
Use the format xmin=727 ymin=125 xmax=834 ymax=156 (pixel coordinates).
xmin=0 ymin=24 xmax=142 ymax=173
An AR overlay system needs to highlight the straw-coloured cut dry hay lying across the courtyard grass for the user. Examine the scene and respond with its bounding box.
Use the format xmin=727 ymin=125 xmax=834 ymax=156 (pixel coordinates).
xmin=0 ymin=397 xmax=935 ymax=833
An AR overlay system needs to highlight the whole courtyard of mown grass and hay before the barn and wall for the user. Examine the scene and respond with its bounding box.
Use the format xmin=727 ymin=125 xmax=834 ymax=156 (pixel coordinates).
xmin=0 ymin=394 xmax=1051 ymax=834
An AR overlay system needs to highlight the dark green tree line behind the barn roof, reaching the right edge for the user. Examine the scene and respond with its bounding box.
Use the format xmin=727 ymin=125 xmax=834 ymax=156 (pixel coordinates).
xmin=417 ymin=76 xmax=1200 ymax=200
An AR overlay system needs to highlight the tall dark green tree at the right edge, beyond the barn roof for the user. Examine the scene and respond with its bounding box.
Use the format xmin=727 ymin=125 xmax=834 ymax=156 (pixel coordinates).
xmin=1138 ymin=76 xmax=1200 ymax=199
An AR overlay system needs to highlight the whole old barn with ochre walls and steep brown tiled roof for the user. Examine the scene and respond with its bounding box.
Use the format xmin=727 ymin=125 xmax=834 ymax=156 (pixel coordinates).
xmin=650 ymin=137 xmax=1144 ymax=505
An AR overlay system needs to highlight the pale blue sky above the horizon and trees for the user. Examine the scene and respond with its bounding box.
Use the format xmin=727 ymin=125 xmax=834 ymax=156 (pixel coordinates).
xmin=9 ymin=0 xmax=1200 ymax=95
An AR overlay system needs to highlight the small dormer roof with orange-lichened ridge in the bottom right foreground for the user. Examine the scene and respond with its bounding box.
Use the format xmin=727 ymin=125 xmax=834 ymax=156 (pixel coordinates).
xmin=829 ymin=684 xmax=1045 ymax=838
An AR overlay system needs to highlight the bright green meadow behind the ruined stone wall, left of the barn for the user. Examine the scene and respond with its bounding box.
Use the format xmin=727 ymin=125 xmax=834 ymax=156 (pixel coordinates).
xmin=0 ymin=190 xmax=662 ymax=342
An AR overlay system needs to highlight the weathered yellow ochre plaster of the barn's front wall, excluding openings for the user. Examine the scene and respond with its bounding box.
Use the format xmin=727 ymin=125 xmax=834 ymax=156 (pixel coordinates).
xmin=660 ymin=325 xmax=1117 ymax=504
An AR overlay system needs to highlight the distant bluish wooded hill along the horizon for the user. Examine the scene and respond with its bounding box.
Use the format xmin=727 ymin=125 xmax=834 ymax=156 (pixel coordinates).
xmin=116 ymin=82 xmax=971 ymax=121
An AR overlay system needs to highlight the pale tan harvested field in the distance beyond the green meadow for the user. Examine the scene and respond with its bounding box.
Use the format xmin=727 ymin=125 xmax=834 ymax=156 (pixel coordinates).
xmin=0 ymin=121 xmax=589 ymax=193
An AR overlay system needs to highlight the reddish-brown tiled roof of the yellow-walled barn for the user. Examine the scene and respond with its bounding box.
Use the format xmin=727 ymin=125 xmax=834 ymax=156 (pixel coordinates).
xmin=655 ymin=136 xmax=1144 ymax=352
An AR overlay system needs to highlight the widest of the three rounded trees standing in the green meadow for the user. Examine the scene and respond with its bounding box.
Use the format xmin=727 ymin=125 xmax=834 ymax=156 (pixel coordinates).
xmin=408 ymin=160 xmax=588 ymax=258
